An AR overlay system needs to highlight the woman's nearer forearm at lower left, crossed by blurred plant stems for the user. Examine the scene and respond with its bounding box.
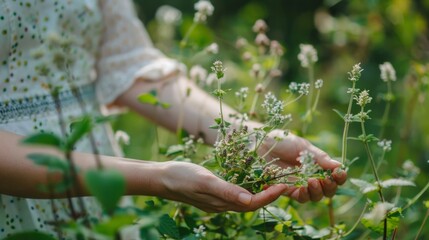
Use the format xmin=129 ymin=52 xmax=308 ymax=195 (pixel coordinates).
xmin=0 ymin=131 xmax=166 ymax=198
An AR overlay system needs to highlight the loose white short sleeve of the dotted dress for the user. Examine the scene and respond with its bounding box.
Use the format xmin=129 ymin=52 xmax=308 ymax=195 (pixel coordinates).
xmin=96 ymin=0 xmax=186 ymax=104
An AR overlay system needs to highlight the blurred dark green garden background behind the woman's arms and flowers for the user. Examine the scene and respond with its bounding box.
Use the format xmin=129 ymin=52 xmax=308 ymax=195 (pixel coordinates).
xmin=114 ymin=0 xmax=429 ymax=239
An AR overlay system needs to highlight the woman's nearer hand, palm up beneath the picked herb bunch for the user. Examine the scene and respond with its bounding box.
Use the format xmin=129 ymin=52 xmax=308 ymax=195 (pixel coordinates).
xmin=160 ymin=161 xmax=287 ymax=212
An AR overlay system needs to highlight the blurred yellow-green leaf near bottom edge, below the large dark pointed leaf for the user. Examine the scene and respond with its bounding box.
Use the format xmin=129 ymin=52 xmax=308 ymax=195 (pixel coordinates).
xmin=94 ymin=214 xmax=137 ymax=237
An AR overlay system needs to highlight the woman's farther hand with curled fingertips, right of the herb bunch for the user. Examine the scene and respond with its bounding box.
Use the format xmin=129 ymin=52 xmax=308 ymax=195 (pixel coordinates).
xmin=260 ymin=130 xmax=347 ymax=203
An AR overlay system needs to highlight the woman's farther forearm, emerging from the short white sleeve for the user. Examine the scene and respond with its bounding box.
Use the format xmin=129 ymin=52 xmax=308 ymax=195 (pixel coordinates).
xmin=116 ymin=77 xmax=259 ymax=144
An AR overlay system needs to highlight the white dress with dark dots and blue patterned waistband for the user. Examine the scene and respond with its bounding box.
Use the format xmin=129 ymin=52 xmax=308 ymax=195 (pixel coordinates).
xmin=0 ymin=0 xmax=181 ymax=239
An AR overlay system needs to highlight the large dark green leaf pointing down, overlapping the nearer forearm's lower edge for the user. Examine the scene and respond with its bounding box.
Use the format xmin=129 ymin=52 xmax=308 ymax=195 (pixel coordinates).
xmin=85 ymin=169 xmax=125 ymax=213
